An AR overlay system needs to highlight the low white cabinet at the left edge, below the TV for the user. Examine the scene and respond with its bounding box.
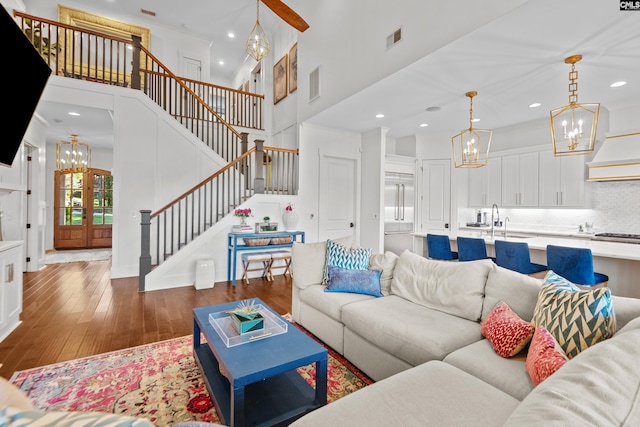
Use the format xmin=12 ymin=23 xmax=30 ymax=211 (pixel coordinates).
xmin=0 ymin=241 xmax=23 ymax=341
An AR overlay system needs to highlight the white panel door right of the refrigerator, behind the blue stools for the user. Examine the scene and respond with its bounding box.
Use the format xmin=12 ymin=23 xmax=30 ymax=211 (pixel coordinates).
xmin=419 ymin=160 xmax=451 ymax=234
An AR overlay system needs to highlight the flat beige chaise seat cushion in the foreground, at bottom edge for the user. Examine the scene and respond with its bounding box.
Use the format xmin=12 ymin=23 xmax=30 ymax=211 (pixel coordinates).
xmin=291 ymin=361 xmax=520 ymax=427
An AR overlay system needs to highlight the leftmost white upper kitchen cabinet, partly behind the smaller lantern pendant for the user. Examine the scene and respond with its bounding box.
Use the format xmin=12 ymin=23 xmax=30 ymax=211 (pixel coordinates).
xmin=469 ymin=157 xmax=502 ymax=207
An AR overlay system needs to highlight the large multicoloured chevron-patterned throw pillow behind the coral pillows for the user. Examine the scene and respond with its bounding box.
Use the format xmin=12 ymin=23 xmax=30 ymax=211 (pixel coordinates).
xmin=532 ymin=271 xmax=616 ymax=359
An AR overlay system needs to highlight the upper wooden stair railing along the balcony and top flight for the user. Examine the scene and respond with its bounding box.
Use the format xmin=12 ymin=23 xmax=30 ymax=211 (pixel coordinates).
xmin=13 ymin=10 xmax=264 ymax=161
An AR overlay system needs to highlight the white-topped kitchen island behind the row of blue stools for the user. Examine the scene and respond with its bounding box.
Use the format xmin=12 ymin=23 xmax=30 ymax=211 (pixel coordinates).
xmin=414 ymin=229 xmax=640 ymax=298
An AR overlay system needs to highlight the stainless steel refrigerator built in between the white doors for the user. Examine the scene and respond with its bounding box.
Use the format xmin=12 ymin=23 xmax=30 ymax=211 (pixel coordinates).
xmin=384 ymin=172 xmax=415 ymax=254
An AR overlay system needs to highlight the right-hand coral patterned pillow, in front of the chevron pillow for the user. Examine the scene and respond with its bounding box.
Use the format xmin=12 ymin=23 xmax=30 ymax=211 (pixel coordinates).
xmin=525 ymin=326 xmax=568 ymax=385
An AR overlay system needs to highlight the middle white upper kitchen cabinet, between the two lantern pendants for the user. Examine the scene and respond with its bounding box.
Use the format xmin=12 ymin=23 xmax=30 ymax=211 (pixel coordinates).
xmin=502 ymin=152 xmax=538 ymax=207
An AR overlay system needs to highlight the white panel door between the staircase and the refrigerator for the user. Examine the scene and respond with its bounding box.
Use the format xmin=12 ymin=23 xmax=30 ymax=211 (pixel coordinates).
xmin=318 ymin=156 xmax=357 ymax=241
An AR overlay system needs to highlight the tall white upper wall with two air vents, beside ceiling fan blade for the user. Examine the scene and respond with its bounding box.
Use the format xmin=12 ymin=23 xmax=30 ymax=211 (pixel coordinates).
xmin=287 ymin=0 xmax=526 ymax=125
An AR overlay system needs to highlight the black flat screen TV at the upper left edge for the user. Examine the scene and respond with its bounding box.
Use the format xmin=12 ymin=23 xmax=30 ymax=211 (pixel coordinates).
xmin=0 ymin=6 xmax=51 ymax=167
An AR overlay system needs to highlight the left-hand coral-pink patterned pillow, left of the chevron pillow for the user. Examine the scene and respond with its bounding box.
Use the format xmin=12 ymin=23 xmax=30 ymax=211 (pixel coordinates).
xmin=481 ymin=302 xmax=535 ymax=357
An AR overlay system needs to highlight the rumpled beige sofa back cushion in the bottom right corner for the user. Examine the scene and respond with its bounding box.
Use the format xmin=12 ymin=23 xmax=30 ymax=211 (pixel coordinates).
xmin=505 ymin=314 xmax=640 ymax=427
